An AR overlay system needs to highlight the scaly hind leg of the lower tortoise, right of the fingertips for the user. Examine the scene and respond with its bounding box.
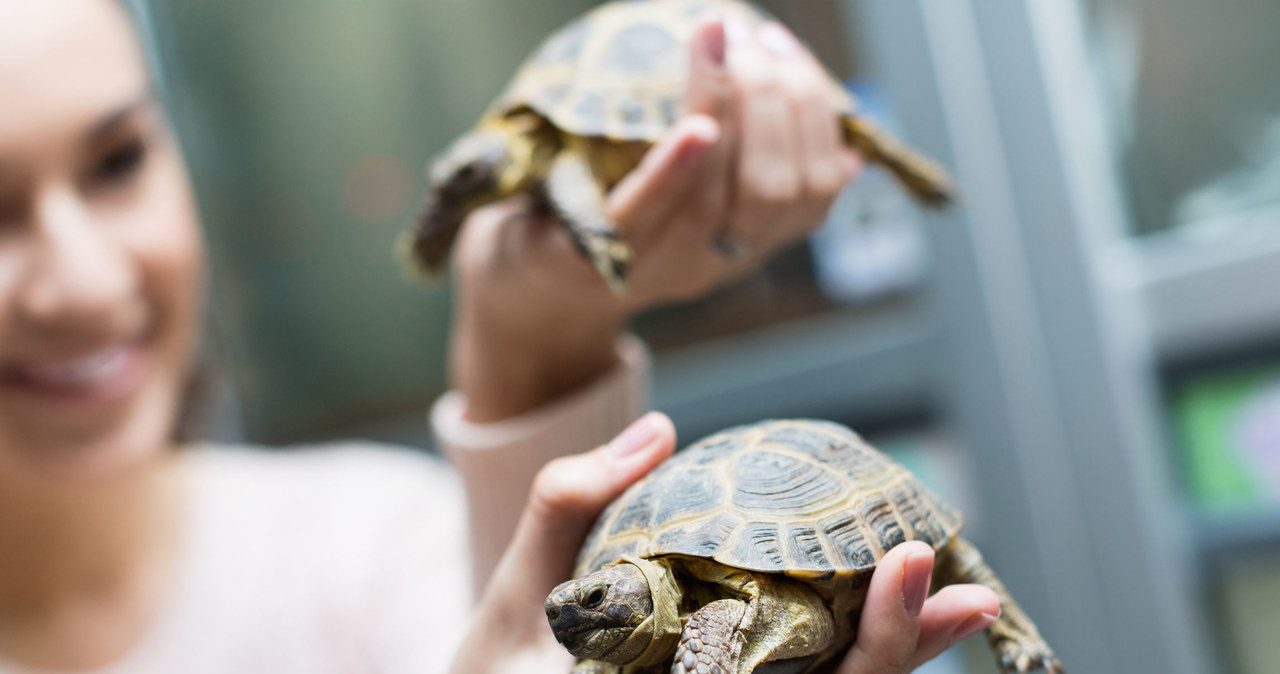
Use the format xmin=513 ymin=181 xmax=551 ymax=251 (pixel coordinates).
xmin=933 ymin=536 xmax=1065 ymax=674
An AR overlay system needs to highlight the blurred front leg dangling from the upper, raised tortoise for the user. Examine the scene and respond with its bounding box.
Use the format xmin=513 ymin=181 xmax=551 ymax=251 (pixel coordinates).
xmin=539 ymin=151 xmax=631 ymax=294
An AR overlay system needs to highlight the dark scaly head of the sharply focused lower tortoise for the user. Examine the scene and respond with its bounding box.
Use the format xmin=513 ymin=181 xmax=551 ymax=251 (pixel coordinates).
xmin=545 ymin=560 xmax=678 ymax=665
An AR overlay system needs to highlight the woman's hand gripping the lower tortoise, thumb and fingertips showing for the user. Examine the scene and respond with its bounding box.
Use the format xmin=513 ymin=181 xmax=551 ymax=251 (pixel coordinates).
xmin=452 ymin=413 xmax=1000 ymax=674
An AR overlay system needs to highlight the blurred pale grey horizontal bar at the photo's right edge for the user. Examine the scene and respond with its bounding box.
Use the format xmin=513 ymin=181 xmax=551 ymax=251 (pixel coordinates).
xmin=1126 ymin=208 xmax=1280 ymax=359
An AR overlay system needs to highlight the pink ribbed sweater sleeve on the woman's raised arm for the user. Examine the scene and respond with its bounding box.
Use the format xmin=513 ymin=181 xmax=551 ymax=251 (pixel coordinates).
xmin=431 ymin=335 xmax=649 ymax=596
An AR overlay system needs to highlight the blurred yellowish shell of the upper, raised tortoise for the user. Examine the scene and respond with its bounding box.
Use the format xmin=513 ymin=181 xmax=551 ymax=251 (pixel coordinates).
xmin=489 ymin=0 xmax=854 ymax=143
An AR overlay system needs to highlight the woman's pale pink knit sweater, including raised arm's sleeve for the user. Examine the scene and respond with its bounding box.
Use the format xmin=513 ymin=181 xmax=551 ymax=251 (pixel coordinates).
xmin=0 ymin=338 xmax=648 ymax=674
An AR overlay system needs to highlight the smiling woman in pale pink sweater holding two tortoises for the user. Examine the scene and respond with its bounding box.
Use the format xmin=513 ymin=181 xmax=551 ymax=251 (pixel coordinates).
xmin=0 ymin=0 xmax=998 ymax=674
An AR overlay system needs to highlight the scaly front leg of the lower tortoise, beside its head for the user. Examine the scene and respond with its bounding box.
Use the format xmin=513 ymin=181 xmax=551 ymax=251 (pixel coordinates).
xmin=671 ymin=599 xmax=750 ymax=674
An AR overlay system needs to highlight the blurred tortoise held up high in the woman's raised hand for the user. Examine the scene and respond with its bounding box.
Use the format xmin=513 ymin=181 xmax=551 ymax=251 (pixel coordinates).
xmin=404 ymin=0 xmax=951 ymax=292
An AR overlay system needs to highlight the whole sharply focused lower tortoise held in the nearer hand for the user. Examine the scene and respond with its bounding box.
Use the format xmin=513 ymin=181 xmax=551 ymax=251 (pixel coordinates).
xmin=545 ymin=419 xmax=1064 ymax=674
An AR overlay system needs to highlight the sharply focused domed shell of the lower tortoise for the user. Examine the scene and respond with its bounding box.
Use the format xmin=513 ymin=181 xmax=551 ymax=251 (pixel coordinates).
xmin=575 ymin=419 xmax=961 ymax=579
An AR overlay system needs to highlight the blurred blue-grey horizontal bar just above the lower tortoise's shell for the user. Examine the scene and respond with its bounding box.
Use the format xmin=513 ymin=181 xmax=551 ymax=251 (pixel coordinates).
xmin=653 ymin=303 xmax=937 ymax=441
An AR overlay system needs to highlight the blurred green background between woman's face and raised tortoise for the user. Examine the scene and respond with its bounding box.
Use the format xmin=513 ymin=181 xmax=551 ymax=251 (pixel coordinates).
xmin=150 ymin=0 xmax=591 ymax=441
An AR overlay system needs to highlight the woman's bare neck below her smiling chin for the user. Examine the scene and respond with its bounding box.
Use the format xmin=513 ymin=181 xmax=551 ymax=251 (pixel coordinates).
xmin=0 ymin=454 xmax=184 ymax=668
